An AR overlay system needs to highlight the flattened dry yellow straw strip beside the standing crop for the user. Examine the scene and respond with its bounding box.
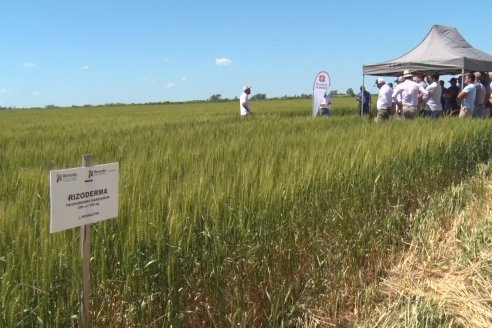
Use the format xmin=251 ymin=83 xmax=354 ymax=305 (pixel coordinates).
xmin=357 ymin=163 xmax=492 ymax=328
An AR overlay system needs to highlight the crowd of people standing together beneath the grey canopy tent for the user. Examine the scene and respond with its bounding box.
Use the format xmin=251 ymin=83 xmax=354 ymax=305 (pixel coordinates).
xmin=364 ymin=70 xmax=492 ymax=122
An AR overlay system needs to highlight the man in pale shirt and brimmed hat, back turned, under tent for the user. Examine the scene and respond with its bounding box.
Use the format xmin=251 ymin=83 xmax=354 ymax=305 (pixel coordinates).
xmin=392 ymin=70 xmax=428 ymax=120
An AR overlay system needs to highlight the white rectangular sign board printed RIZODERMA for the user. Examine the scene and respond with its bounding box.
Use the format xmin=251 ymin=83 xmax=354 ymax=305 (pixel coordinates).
xmin=50 ymin=163 xmax=119 ymax=233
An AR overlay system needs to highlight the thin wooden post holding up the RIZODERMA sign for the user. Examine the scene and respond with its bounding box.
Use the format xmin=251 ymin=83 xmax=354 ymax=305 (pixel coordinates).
xmin=80 ymin=154 xmax=92 ymax=328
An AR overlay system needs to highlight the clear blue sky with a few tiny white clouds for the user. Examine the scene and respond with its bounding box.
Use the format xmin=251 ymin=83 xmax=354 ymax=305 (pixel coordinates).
xmin=0 ymin=0 xmax=492 ymax=108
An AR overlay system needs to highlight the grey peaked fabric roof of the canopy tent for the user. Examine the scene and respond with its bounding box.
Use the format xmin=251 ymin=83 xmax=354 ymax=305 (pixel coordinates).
xmin=363 ymin=25 xmax=492 ymax=76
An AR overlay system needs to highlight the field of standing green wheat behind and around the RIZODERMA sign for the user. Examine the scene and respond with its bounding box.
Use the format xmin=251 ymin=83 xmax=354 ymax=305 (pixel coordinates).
xmin=0 ymin=98 xmax=492 ymax=327
